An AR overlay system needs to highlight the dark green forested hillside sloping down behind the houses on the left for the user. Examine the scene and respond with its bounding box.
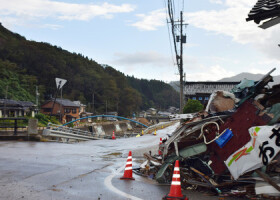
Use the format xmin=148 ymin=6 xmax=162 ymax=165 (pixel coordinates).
xmin=0 ymin=24 xmax=179 ymax=115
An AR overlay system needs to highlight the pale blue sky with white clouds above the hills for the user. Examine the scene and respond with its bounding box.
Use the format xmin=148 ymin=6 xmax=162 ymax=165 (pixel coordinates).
xmin=0 ymin=0 xmax=280 ymax=82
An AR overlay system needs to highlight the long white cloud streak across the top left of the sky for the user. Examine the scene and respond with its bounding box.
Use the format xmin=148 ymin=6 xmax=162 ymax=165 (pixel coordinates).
xmin=0 ymin=0 xmax=134 ymax=21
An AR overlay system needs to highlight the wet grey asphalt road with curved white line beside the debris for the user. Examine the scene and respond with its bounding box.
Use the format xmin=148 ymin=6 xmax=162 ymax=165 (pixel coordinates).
xmin=0 ymin=124 xmax=241 ymax=200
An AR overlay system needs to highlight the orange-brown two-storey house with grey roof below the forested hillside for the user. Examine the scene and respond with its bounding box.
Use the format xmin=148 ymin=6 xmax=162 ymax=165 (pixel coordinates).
xmin=41 ymin=98 xmax=80 ymax=123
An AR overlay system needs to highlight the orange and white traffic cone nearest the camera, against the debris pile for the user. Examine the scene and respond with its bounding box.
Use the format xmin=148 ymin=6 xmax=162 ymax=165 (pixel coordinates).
xmin=162 ymin=160 xmax=188 ymax=200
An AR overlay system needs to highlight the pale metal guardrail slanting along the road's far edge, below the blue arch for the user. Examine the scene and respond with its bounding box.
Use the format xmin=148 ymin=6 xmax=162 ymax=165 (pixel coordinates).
xmin=43 ymin=123 xmax=104 ymax=141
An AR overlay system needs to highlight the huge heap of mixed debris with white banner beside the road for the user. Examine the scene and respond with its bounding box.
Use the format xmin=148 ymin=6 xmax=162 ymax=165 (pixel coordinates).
xmin=135 ymin=69 xmax=280 ymax=199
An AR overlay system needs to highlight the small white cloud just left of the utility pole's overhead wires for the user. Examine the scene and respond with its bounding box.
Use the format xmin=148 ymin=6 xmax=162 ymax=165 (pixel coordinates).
xmin=131 ymin=9 xmax=166 ymax=31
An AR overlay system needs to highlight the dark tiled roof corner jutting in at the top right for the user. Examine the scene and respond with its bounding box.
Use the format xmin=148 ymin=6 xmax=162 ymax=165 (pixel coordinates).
xmin=246 ymin=0 xmax=280 ymax=24
